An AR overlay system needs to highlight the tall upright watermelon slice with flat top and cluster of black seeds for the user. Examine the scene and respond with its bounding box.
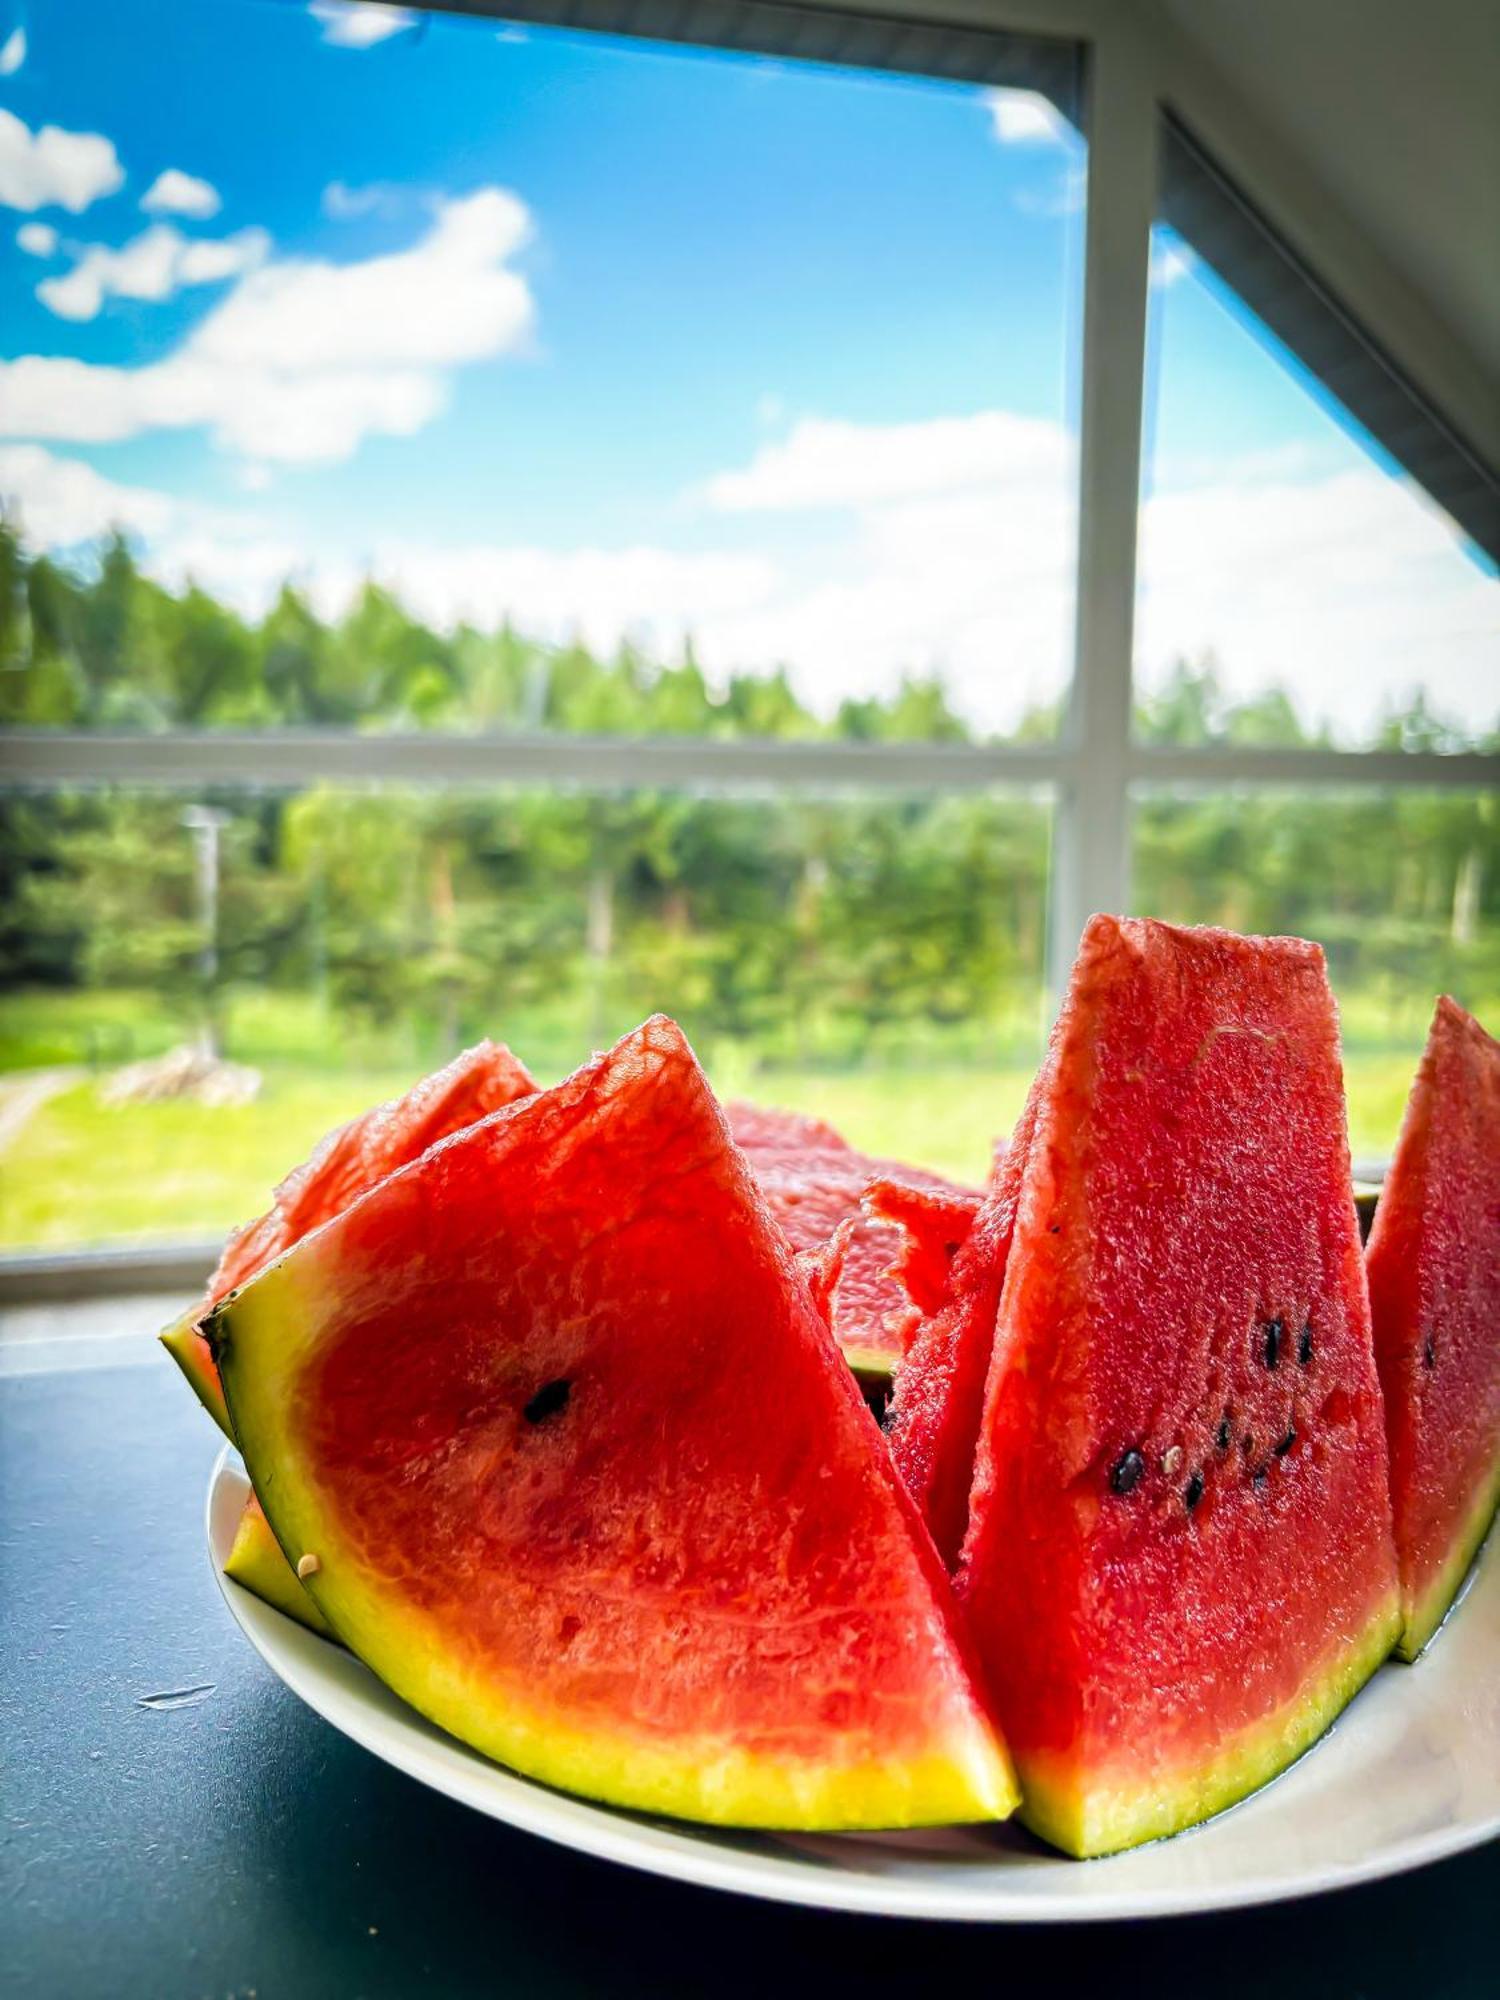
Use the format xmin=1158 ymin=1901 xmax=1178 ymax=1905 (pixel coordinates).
xmin=960 ymin=918 xmax=1400 ymax=1854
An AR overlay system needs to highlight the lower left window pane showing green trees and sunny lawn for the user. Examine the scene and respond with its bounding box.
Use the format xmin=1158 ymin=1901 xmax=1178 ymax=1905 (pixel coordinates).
xmin=0 ymin=786 xmax=1050 ymax=1248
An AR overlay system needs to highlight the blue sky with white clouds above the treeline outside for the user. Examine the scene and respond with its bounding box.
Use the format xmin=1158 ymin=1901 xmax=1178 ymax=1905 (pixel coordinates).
xmin=0 ymin=0 xmax=1494 ymax=734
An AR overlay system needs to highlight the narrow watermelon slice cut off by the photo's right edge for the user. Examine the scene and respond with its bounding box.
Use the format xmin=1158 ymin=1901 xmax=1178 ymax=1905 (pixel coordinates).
xmin=1366 ymin=996 xmax=1500 ymax=1660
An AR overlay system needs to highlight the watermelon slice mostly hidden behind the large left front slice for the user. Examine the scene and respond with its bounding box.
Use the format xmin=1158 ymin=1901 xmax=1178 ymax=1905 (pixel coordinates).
xmin=162 ymin=1042 xmax=536 ymax=1438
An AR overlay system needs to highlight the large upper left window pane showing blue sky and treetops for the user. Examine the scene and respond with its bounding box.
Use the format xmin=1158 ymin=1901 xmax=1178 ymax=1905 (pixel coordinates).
xmin=0 ymin=0 xmax=1082 ymax=738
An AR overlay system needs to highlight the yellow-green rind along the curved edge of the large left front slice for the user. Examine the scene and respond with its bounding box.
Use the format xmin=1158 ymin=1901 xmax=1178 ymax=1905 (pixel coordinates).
xmin=208 ymin=1238 xmax=1018 ymax=1832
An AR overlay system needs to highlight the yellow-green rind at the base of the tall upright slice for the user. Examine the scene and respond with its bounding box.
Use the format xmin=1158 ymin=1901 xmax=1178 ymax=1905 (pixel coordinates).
xmin=1020 ymin=1590 xmax=1402 ymax=1860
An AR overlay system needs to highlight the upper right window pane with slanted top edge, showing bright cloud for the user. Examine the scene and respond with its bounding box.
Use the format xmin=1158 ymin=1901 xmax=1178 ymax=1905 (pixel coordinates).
xmin=1136 ymin=226 xmax=1500 ymax=750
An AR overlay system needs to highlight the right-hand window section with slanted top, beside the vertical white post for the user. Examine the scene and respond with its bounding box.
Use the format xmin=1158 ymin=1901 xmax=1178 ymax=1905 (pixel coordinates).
xmin=1132 ymin=107 xmax=1500 ymax=1104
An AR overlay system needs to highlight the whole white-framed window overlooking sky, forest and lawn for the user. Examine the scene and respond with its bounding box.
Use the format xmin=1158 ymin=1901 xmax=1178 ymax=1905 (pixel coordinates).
xmin=0 ymin=0 xmax=1500 ymax=1256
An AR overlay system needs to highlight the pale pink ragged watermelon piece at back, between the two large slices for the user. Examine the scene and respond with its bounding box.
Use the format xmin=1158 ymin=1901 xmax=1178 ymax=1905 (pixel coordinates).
xmin=728 ymin=1104 xmax=980 ymax=1380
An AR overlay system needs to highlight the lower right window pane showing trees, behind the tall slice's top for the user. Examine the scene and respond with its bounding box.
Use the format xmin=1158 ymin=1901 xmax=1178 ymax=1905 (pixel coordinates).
xmin=1134 ymin=790 xmax=1500 ymax=1158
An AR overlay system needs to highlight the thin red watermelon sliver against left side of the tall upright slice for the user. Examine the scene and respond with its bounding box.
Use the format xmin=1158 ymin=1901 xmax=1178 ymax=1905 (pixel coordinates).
xmin=886 ymin=1078 xmax=1040 ymax=1568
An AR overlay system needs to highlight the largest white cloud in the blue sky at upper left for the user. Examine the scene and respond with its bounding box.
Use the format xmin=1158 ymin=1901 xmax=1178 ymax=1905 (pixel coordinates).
xmin=0 ymin=188 xmax=534 ymax=464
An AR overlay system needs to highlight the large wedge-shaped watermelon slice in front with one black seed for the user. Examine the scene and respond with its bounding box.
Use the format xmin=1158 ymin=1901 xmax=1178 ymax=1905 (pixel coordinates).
xmin=208 ymin=1018 xmax=1014 ymax=1828
